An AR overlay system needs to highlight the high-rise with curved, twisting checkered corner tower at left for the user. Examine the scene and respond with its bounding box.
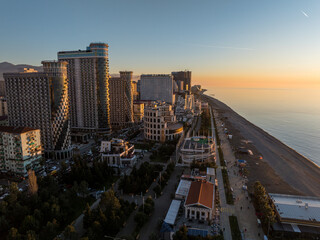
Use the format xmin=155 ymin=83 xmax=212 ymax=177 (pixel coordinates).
xmin=3 ymin=61 xmax=71 ymax=159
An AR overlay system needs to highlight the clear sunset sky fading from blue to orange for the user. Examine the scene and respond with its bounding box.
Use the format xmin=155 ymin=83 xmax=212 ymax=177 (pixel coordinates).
xmin=0 ymin=0 xmax=320 ymax=88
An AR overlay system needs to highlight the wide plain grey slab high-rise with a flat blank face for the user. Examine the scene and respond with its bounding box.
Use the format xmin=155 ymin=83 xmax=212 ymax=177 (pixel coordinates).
xmin=140 ymin=74 xmax=174 ymax=104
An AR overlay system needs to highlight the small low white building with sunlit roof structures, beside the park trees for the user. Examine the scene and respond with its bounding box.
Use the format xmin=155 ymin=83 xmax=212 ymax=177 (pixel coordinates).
xmin=100 ymin=138 xmax=137 ymax=168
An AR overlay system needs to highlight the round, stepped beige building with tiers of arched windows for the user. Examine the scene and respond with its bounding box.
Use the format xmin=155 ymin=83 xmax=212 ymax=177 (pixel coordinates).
xmin=144 ymin=103 xmax=183 ymax=142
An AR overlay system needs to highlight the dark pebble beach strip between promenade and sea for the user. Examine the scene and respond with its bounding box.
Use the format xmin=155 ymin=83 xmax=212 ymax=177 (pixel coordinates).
xmin=200 ymin=94 xmax=320 ymax=197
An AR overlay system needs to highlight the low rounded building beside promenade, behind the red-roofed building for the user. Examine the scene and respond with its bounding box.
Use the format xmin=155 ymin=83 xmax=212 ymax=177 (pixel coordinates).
xmin=180 ymin=136 xmax=215 ymax=164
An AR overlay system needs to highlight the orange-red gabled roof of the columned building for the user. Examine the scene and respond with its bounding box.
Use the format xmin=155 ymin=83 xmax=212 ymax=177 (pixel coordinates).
xmin=185 ymin=181 xmax=214 ymax=208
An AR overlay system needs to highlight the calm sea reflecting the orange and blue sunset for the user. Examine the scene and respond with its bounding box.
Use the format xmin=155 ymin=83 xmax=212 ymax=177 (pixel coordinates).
xmin=206 ymin=88 xmax=320 ymax=166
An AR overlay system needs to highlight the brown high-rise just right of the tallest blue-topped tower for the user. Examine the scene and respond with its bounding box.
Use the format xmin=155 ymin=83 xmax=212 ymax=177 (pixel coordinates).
xmin=109 ymin=71 xmax=133 ymax=128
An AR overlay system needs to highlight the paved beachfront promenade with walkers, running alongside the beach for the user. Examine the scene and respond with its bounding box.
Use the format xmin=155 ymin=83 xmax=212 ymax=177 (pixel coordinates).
xmin=209 ymin=102 xmax=263 ymax=240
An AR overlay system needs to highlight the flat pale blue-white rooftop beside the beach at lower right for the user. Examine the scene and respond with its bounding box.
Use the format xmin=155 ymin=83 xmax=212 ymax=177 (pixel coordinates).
xmin=269 ymin=193 xmax=320 ymax=222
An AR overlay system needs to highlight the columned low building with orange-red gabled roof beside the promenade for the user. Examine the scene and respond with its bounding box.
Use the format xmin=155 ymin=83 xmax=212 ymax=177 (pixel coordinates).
xmin=184 ymin=181 xmax=214 ymax=221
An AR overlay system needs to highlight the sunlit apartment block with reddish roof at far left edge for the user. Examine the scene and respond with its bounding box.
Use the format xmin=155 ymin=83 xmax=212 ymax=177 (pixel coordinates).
xmin=0 ymin=127 xmax=42 ymax=175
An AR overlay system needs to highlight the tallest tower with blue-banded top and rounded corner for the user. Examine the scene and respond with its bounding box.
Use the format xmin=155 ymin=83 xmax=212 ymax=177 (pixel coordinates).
xmin=58 ymin=43 xmax=111 ymax=134
